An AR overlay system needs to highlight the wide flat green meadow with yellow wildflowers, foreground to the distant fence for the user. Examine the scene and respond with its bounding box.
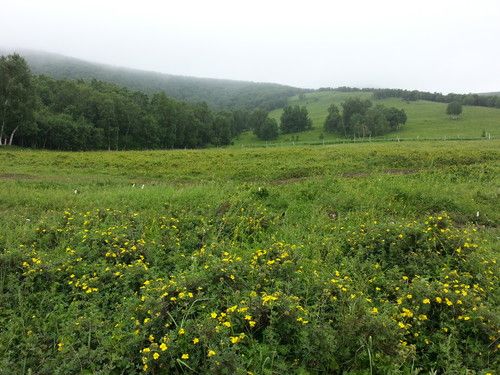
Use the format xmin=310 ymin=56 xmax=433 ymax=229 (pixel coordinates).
xmin=0 ymin=142 xmax=500 ymax=375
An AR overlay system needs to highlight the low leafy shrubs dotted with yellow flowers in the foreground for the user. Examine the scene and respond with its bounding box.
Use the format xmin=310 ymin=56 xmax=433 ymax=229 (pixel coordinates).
xmin=0 ymin=207 xmax=498 ymax=373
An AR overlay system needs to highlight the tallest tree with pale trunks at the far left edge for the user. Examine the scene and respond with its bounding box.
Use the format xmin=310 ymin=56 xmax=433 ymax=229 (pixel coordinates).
xmin=0 ymin=54 xmax=35 ymax=145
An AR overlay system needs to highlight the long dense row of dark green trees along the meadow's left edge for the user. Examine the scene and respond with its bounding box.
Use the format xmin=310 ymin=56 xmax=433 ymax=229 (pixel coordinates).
xmin=0 ymin=54 xmax=258 ymax=150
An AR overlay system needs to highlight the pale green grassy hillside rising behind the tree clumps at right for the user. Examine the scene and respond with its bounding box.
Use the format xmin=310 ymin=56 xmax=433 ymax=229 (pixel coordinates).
xmin=235 ymin=92 xmax=500 ymax=146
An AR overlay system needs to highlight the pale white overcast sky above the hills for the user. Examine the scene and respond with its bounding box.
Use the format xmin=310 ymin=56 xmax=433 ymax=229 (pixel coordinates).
xmin=0 ymin=0 xmax=500 ymax=93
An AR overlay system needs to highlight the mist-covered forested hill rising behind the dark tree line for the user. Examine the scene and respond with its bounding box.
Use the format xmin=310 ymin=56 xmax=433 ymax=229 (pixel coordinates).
xmin=0 ymin=48 xmax=307 ymax=110
